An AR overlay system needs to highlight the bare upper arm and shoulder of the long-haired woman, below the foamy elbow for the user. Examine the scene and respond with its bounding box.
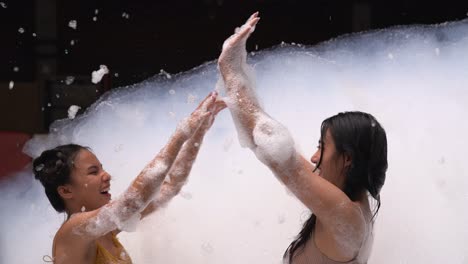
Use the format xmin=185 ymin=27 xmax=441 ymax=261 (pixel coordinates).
xmin=270 ymin=153 xmax=367 ymax=256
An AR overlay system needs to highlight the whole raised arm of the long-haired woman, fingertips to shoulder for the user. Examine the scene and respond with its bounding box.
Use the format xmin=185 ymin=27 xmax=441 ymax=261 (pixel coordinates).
xmin=218 ymin=13 xmax=361 ymax=230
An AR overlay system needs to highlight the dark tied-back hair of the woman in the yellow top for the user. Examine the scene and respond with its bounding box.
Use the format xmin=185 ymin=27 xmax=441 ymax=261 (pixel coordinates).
xmin=33 ymin=144 xmax=89 ymax=213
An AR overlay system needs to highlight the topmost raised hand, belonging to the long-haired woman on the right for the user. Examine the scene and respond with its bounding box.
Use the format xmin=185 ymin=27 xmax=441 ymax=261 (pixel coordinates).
xmin=218 ymin=12 xmax=260 ymax=79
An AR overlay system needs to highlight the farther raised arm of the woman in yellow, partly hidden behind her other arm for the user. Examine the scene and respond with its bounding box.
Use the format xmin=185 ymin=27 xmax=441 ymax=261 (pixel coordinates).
xmin=141 ymin=95 xmax=226 ymax=218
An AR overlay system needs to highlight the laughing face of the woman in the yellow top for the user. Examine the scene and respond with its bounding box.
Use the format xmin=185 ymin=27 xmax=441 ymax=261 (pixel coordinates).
xmin=68 ymin=149 xmax=111 ymax=211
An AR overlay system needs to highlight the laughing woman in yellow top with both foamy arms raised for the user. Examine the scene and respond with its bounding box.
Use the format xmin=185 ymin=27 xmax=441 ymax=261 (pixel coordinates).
xmin=33 ymin=92 xmax=225 ymax=264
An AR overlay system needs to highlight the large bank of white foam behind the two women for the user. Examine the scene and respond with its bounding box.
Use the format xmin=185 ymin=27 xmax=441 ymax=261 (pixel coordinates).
xmin=0 ymin=21 xmax=468 ymax=264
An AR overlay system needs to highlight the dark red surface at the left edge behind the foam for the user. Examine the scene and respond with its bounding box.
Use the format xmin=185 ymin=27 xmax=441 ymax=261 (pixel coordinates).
xmin=0 ymin=131 xmax=31 ymax=179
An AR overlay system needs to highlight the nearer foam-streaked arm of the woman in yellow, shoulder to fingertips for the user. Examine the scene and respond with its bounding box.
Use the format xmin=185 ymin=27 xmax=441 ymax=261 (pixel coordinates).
xmin=63 ymin=93 xmax=221 ymax=242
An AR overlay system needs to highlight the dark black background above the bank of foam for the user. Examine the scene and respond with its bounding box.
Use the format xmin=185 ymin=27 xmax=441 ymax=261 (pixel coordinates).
xmin=0 ymin=0 xmax=468 ymax=135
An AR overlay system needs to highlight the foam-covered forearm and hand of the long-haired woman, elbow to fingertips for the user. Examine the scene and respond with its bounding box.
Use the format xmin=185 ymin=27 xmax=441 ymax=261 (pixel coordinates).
xmin=218 ymin=13 xmax=295 ymax=169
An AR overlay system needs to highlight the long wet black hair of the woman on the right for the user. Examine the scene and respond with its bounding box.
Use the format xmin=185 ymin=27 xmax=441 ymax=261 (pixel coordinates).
xmin=283 ymin=111 xmax=388 ymax=263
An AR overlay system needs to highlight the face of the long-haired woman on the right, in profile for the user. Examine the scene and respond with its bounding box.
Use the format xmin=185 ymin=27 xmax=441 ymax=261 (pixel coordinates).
xmin=311 ymin=129 xmax=351 ymax=190
